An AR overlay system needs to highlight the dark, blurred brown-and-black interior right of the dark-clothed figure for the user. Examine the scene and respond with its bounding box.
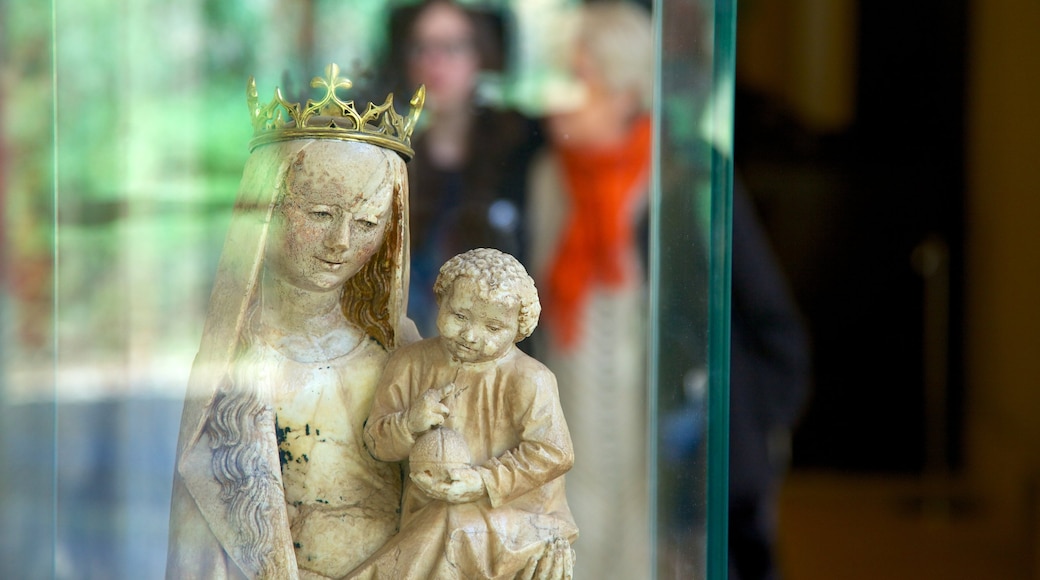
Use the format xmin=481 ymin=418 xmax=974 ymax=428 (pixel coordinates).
xmin=735 ymin=0 xmax=1040 ymax=578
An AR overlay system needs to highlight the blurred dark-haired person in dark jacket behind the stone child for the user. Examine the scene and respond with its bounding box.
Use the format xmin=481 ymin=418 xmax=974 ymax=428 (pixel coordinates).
xmin=391 ymin=0 xmax=542 ymax=337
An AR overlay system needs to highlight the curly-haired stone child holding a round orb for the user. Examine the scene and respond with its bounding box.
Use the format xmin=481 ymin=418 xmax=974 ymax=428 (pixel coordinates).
xmin=352 ymin=248 xmax=577 ymax=579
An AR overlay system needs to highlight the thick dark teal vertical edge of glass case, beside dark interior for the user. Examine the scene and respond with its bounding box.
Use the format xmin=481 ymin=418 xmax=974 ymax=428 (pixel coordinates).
xmin=707 ymin=0 xmax=736 ymax=580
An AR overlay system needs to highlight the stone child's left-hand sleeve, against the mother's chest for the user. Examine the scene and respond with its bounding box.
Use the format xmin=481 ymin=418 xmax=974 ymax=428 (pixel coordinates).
xmin=364 ymin=349 xmax=415 ymax=462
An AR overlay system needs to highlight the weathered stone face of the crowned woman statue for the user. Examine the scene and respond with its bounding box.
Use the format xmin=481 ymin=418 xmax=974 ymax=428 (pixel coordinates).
xmin=265 ymin=141 xmax=399 ymax=292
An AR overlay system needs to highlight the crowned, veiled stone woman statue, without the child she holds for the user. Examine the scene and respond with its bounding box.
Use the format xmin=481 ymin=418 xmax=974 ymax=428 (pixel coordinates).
xmin=166 ymin=65 xmax=424 ymax=579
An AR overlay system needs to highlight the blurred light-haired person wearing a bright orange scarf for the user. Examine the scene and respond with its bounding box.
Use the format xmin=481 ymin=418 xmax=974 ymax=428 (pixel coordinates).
xmin=528 ymin=2 xmax=653 ymax=578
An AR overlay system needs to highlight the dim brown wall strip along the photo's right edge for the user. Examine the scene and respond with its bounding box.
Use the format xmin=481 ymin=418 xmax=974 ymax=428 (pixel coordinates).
xmin=966 ymin=0 xmax=1040 ymax=565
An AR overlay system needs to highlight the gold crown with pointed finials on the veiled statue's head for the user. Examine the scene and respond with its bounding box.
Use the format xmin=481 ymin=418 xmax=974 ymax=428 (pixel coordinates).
xmin=245 ymin=63 xmax=426 ymax=160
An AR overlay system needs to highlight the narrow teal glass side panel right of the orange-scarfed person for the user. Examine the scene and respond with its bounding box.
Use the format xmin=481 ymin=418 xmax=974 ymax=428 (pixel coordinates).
xmin=650 ymin=0 xmax=732 ymax=578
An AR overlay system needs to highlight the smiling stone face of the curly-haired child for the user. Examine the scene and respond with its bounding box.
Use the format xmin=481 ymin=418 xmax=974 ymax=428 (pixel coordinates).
xmin=437 ymin=278 xmax=520 ymax=363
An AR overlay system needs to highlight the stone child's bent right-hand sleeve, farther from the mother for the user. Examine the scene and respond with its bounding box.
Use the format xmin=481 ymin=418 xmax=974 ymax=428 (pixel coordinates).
xmin=480 ymin=366 xmax=574 ymax=507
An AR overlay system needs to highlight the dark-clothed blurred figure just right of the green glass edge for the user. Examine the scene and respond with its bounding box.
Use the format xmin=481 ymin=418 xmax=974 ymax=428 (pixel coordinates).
xmin=729 ymin=179 xmax=810 ymax=580
